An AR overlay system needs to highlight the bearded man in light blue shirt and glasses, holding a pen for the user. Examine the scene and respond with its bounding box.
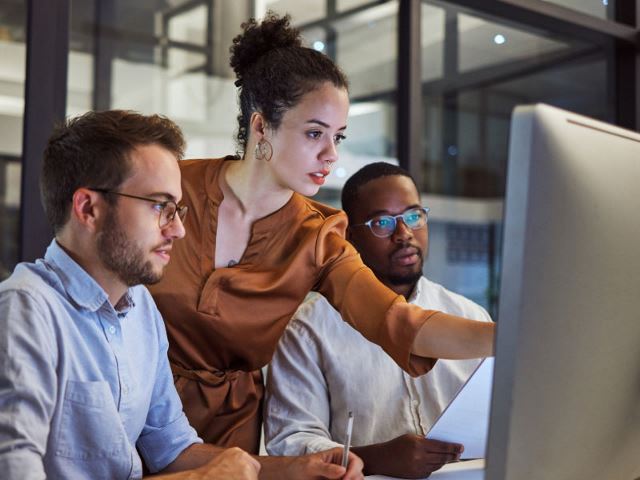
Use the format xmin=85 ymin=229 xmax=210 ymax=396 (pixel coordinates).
xmin=0 ymin=110 xmax=361 ymax=480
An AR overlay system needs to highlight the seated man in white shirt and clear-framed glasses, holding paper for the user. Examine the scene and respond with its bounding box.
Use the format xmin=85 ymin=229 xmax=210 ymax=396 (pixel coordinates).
xmin=265 ymin=163 xmax=491 ymax=478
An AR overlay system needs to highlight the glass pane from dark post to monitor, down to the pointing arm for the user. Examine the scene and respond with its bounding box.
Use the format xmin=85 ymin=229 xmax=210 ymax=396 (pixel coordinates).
xmin=421 ymin=2 xmax=613 ymax=315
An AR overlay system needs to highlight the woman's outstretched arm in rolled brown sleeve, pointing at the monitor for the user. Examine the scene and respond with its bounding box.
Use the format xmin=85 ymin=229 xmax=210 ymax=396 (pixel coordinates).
xmin=316 ymin=224 xmax=495 ymax=375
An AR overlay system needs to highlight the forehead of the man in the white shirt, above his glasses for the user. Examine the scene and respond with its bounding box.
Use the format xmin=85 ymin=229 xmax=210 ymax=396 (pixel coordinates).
xmin=358 ymin=175 xmax=420 ymax=215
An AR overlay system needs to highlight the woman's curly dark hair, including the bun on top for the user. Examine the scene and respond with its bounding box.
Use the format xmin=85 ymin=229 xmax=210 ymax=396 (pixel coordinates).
xmin=230 ymin=12 xmax=349 ymax=156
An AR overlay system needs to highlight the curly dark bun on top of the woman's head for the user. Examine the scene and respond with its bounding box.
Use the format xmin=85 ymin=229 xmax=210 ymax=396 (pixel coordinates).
xmin=229 ymin=11 xmax=302 ymax=86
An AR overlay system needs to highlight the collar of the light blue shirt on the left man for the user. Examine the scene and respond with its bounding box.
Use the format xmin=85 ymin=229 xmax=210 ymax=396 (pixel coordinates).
xmin=44 ymin=239 xmax=134 ymax=314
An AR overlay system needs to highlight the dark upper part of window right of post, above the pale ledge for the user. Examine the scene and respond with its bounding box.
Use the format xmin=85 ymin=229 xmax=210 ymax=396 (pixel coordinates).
xmin=423 ymin=5 xmax=612 ymax=198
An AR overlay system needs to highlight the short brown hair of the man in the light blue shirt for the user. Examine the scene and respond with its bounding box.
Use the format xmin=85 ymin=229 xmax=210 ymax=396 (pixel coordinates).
xmin=40 ymin=110 xmax=185 ymax=233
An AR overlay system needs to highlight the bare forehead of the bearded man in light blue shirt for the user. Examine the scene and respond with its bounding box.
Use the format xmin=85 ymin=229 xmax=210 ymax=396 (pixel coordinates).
xmin=121 ymin=145 xmax=182 ymax=198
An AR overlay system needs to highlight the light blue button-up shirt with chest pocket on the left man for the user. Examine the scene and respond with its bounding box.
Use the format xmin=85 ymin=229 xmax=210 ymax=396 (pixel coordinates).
xmin=0 ymin=240 xmax=201 ymax=480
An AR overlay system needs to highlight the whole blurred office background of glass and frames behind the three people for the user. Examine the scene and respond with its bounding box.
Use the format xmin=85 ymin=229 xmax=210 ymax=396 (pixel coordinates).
xmin=0 ymin=0 xmax=640 ymax=315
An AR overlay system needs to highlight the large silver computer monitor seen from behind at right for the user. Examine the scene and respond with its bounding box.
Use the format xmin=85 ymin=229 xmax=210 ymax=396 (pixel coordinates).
xmin=485 ymin=105 xmax=640 ymax=480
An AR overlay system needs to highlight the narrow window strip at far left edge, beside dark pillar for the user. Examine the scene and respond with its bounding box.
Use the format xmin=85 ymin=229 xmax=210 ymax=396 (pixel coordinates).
xmin=0 ymin=1 xmax=27 ymax=280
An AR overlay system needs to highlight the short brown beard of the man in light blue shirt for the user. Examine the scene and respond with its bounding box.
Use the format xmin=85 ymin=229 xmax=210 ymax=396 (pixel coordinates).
xmin=97 ymin=210 xmax=162 ymax=287
